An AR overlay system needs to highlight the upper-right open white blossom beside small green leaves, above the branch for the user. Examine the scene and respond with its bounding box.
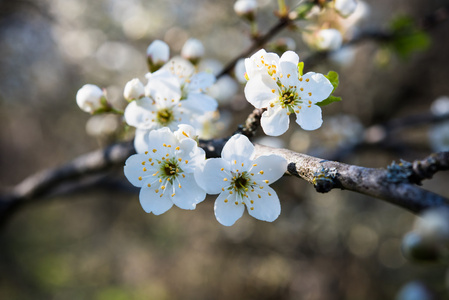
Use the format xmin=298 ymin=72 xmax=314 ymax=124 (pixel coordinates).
xmin=245 ymin=51 xmax=333 ymax=136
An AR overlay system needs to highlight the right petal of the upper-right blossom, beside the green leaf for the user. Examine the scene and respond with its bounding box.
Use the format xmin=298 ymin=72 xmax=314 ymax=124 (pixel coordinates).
xmin=301 ymin=72 xmax=334 ymax=103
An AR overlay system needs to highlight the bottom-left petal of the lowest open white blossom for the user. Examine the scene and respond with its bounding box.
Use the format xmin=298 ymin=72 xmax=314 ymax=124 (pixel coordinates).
xmin=214 ymin=192 xmax=245 ymax=226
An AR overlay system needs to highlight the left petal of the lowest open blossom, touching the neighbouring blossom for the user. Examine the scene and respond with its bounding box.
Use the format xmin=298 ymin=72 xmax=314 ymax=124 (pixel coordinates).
xmin=194 ymin=158 xmax=230 ymax=195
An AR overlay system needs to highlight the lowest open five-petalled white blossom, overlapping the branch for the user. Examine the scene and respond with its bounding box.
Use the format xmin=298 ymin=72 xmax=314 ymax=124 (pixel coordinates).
xmin=195 ymin=134 xmax=287 ymax=226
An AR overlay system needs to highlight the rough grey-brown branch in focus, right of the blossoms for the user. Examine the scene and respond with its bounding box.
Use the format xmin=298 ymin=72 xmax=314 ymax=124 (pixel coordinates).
xmin=256 ymin=145 xmax=449 ymax=213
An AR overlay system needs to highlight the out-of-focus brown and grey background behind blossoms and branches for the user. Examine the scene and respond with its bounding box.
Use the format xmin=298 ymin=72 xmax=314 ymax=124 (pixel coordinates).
xmin=0 ymin=0 xmax=449 ymax=300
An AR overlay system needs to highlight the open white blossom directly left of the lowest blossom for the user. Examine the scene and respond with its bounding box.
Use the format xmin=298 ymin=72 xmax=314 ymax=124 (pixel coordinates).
xmin=124 ymin=127 xmax=206 ymax=215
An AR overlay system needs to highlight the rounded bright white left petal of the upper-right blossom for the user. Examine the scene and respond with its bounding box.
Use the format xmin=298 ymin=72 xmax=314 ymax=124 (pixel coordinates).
xmin=245 ymin=75 xmax=279 ymax=108
